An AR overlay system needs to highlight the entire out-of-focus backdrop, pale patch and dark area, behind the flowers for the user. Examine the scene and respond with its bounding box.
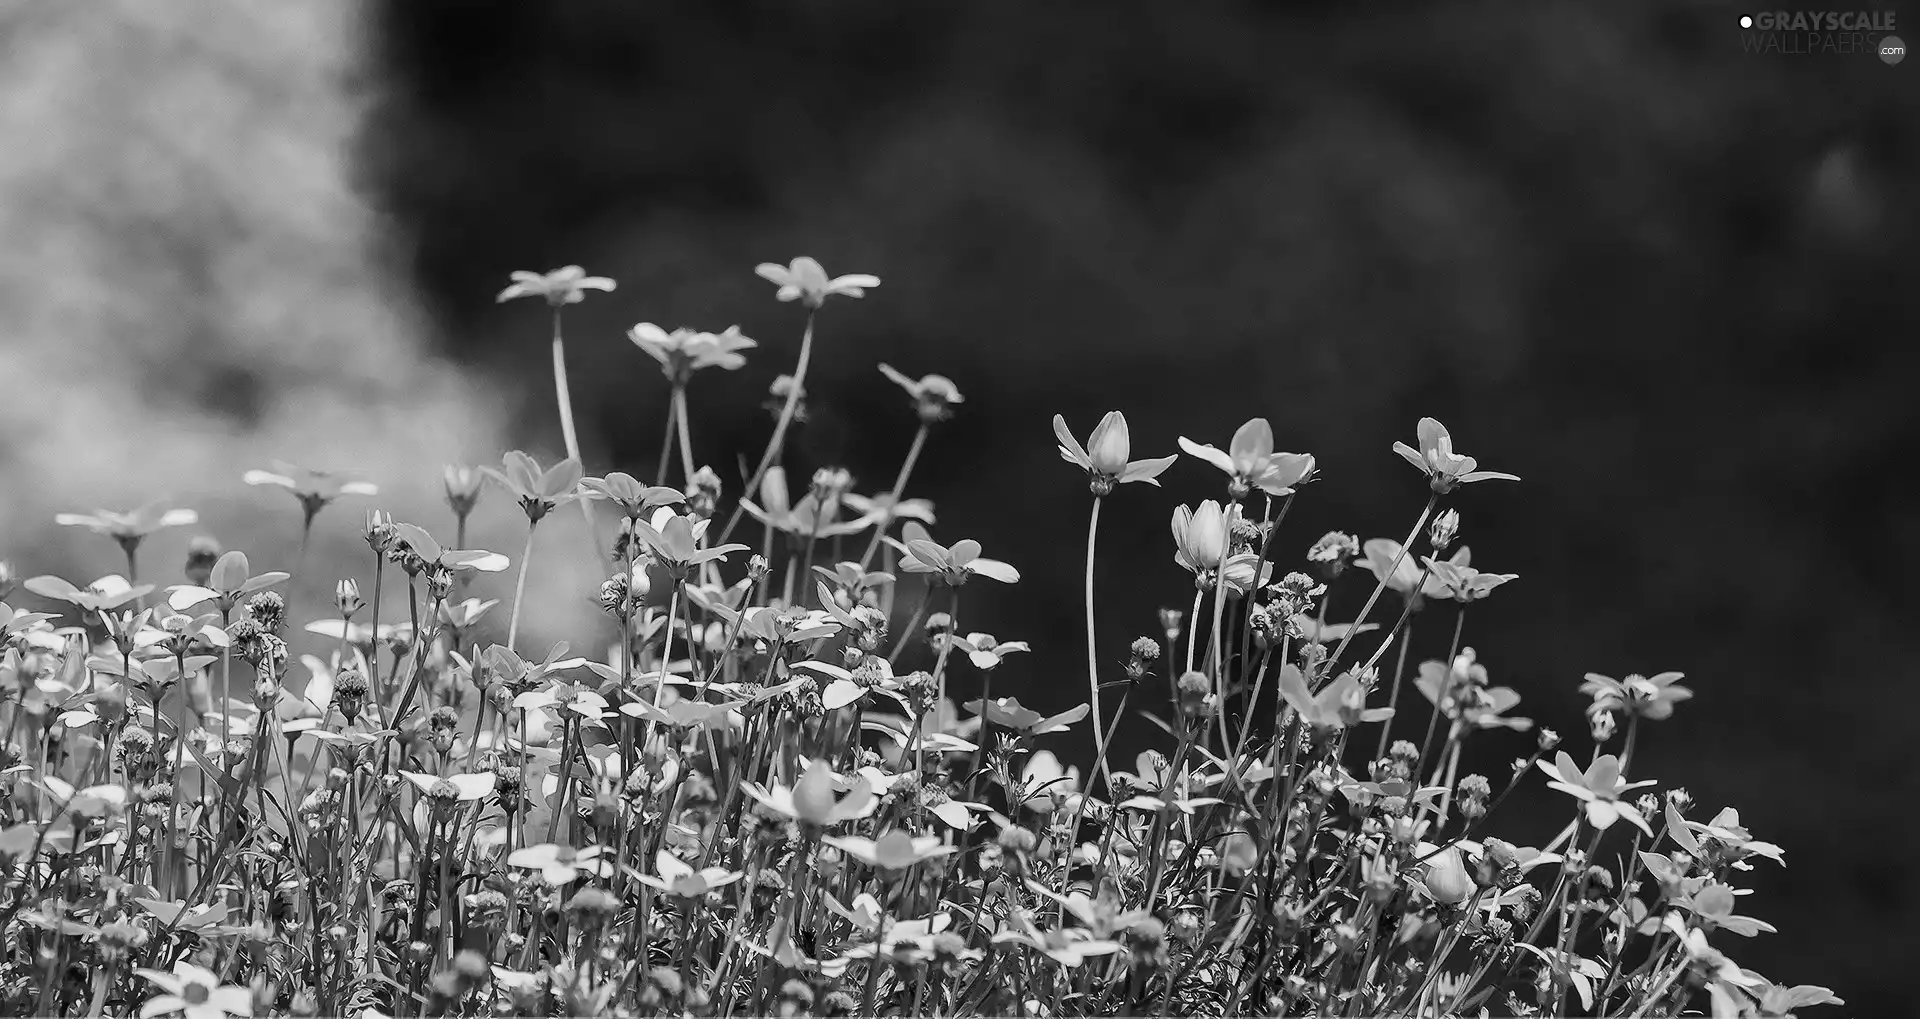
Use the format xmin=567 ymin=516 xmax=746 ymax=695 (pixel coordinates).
xmin=0 ymin=0 xmax=1920 ymax=1015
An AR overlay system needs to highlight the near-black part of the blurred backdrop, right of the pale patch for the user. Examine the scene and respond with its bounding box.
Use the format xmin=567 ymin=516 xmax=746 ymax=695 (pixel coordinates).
xmin=361 ymin=0 xmax=1920 ymax=1015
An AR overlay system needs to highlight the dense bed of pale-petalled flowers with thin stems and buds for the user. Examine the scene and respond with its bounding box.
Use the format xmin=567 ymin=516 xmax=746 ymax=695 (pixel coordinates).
xmin=0 ymin=259 xmax=1837 ymax=1019
